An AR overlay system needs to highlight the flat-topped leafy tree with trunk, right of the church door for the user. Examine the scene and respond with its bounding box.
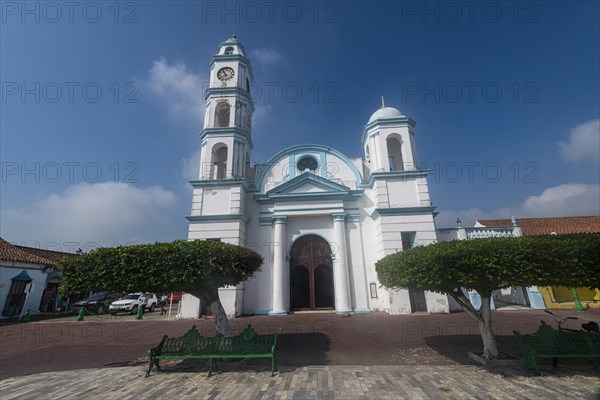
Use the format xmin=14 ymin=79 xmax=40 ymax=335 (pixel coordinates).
xmin=375 ymin=235 xmax=600 ymax=359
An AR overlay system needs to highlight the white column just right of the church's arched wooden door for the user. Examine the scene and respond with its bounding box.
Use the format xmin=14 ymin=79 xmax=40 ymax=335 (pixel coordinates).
xmin=332 ymin=213 xmax=352 ymax=313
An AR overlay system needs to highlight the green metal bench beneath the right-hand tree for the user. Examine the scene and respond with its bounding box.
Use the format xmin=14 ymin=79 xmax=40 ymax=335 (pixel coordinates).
xmin=513 ymin=321 xmax=600 ymax=375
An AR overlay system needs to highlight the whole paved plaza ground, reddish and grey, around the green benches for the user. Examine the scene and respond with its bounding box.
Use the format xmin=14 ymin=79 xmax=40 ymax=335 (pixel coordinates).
xmin=0 ymin=310 xmax=600 ymax=400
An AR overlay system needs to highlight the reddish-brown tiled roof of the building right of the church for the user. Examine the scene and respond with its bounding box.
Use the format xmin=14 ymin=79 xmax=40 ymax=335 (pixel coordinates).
xmin=478 ymin=216 xmax=600 ymax=236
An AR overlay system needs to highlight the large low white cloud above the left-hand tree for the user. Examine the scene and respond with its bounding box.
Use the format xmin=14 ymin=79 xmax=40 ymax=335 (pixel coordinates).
xmin=2 ymin=182 xmax=178 ymax=251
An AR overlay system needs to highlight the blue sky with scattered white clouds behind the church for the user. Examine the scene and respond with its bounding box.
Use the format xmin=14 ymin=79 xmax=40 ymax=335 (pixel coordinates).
xmin=0 ymin=1 xmax=600 ymax=251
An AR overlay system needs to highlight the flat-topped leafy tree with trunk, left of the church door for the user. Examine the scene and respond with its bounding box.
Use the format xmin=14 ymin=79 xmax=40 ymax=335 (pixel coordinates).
xmin=60 ymin=240 xmax=263 ymax=335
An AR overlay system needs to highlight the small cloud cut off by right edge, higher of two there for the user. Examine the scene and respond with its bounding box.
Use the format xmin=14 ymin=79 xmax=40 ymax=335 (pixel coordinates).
xmin=558 ymin=119 xmax=600 ymax=163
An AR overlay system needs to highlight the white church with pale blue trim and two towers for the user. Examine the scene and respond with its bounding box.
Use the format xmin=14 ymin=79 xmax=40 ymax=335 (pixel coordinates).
xmin=181 ymin=36 xmax=449 ymax=317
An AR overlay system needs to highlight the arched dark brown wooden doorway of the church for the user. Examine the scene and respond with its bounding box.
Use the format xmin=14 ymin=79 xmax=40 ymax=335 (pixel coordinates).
xmin=290 ymin=235 xmax=334 ymax=310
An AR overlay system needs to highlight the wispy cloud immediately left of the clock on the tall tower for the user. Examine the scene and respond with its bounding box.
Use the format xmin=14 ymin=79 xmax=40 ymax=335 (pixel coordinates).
xmin=142 ymin=58 xmax=204 ymax=126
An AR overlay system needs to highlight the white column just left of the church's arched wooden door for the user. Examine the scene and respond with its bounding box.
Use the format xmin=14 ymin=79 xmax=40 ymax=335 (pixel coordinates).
xmin=269 ymin=216 xmax=288 ymax=315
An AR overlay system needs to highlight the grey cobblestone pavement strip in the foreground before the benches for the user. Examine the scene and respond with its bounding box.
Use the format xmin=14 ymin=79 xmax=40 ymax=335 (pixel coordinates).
xmin=0 ymin=361 xmax=600 ymax=400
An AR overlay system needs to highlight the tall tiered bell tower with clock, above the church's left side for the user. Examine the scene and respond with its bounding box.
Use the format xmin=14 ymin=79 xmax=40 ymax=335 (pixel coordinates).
xmin=200 ymin=35 xmax=254 ymax=180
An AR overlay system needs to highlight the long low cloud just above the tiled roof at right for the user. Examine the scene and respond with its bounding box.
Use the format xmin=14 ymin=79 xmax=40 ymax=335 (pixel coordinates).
xmin=435 ymin=183 xmax=600 ymax=228
